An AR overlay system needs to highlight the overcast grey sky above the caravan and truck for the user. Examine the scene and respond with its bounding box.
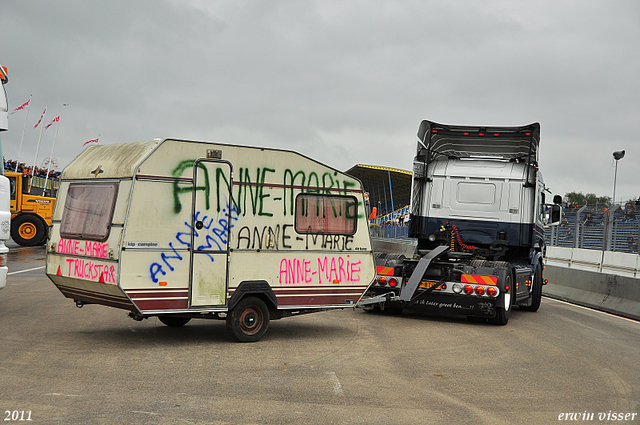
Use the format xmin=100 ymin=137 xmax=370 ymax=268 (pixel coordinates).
xmin=0 ymin=0 xmax=640 ymax=201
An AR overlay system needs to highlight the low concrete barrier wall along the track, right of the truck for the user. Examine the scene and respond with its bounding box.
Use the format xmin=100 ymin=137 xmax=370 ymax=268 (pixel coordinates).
xmin=542 ymin=247 xmax=640 ymax=320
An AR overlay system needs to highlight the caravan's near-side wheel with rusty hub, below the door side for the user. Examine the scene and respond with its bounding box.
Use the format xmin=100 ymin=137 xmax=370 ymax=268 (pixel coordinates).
xmin=227 ymin=297 xmax=269 ymax=342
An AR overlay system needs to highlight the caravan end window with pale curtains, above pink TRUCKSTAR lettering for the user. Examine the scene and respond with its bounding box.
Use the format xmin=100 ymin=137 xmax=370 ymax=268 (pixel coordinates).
xmin=60 ymin=182 xmax=118 ymax=242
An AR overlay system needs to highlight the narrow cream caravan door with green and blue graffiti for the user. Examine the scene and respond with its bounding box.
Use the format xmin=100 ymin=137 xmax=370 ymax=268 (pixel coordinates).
xmin=189 ymin=159 xmax=233 ymax=308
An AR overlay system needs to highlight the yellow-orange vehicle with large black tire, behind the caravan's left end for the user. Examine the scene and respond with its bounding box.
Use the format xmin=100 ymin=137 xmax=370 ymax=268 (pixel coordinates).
xmin=5 ymin=172 xmax=57 ymax=246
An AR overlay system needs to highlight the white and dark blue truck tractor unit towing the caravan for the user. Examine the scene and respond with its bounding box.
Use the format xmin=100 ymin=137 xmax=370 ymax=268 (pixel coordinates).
xmin=362 ymin=120 xmax=556 ymax=325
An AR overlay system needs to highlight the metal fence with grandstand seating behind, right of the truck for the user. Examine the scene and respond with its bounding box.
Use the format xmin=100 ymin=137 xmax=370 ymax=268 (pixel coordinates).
xmin=545 ymin=206 xmax=640 ymax=253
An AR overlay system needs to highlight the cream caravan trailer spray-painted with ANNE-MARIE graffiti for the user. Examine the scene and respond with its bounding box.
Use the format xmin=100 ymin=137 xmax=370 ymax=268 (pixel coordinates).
xmin=47 ymin=140 xmax=375 ymax=341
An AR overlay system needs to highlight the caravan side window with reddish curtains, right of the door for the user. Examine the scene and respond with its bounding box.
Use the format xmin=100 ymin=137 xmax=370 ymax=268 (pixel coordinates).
xmin=295 ymin=193 xmax=358 ymax=235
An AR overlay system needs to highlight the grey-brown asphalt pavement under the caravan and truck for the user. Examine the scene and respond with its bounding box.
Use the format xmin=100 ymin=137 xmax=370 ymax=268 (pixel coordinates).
xmin=0 ymin=243 xmax=640 ymax=424
